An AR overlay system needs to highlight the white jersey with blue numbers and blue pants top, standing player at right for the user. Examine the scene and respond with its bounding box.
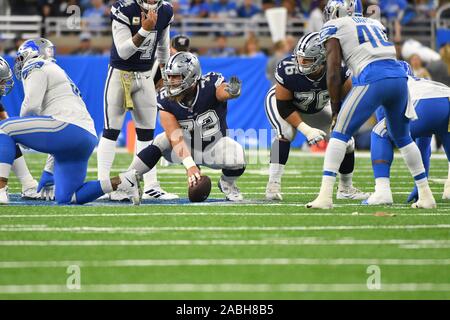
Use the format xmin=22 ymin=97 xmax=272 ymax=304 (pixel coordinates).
xmin=320 ymin=16 xmax=406 ymax=85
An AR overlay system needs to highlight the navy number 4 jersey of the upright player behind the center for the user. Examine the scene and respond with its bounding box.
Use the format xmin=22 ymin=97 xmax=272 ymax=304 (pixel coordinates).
xmin=110 ymin=0 xmax=173 ymax=71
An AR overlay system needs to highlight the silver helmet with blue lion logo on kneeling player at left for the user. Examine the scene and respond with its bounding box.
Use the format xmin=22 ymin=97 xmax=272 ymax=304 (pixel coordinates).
xmin=14 ymin=38 xmax=55 ymax=80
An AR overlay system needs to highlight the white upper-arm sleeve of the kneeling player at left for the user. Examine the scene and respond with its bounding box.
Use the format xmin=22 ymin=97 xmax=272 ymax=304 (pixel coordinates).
xmin=20 ymin=69 xmax=47 ymax=117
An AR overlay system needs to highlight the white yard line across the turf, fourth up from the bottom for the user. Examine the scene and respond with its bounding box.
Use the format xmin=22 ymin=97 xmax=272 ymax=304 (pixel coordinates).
xmin=0 ymin=224 xmax=450 ymax=233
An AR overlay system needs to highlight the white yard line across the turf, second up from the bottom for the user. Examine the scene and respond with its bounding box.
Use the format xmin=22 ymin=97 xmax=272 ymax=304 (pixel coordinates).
xmin=0 ymin=258 xmax=450 ymax=269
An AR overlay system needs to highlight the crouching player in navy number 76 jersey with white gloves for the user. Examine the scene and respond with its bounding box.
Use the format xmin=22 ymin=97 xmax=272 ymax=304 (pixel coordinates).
xmin=265 ymin=32 xmax=369 ymax=200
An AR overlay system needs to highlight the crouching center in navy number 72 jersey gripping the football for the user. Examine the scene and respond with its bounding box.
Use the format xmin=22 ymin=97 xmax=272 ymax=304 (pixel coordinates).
xmin=126 ymin=52 xmax=245 ymax=201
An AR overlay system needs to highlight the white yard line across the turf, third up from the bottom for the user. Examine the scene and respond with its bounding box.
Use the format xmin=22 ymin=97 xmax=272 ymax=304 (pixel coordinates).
xmin=0 ymin=238 xmax=450 ymax=249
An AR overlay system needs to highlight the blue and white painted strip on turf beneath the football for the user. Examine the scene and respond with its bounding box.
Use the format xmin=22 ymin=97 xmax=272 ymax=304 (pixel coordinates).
xmin=9 ymin=194 xmax=264 ymax=207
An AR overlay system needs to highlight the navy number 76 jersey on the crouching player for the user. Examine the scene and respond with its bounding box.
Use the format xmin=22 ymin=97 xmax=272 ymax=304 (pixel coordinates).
xmin=275 ymin=56 xmax=350 ymax=113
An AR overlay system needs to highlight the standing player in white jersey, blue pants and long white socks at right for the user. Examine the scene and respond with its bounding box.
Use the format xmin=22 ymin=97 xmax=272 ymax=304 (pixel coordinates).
xmin=306 ymin=0 xmax=436 ymax=209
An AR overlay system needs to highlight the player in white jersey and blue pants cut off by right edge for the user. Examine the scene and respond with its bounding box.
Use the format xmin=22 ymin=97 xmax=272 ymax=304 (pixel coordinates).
xmin=363 ymin=61 xmax=450 ymax=205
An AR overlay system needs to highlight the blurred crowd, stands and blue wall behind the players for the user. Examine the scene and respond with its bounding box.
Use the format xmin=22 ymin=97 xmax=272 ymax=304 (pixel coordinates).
xmin=0 ymin=0 xmax=450 ymax=150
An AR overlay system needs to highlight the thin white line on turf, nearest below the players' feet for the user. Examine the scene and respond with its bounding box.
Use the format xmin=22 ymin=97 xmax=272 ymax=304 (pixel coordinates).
xmin=0 ymin=210 xmax=450 ymax=219
